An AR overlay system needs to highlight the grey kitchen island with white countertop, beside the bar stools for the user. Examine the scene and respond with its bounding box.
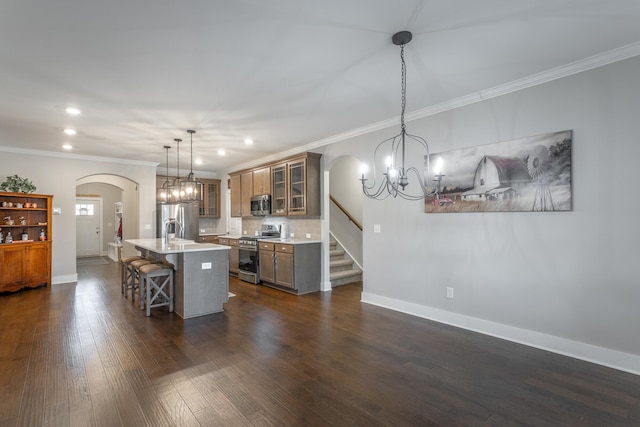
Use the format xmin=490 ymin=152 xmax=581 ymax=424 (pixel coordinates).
xmin=126 ymin=239 xmax=229 ymax=319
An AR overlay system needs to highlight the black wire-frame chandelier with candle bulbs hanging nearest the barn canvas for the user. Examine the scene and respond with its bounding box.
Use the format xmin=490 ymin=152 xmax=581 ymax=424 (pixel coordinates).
xmin=360 ymin=31 xmax=444 ymax=200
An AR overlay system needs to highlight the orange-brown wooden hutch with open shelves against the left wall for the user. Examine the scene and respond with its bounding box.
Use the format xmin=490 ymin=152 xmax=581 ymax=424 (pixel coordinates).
xmin=0 ymin=192 xmax=53 ymax=292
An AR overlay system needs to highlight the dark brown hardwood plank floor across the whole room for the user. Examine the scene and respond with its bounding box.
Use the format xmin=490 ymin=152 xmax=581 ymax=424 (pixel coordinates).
xmin=0 ymin=263 xmax=640 ymax=427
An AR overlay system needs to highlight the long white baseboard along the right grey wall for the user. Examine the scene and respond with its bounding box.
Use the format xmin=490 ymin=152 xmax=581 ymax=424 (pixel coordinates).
xmin=361 ymin=292 xmax=640 ymax=375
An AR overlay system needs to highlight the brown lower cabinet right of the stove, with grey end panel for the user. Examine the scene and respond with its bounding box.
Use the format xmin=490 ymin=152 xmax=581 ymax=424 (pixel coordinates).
xmin=259 ymin=242 xmax=321 ymax=294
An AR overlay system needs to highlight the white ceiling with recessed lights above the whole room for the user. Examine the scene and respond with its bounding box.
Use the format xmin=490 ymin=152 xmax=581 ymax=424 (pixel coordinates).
xmin=0 ymin=0 xmax=640 ymax=171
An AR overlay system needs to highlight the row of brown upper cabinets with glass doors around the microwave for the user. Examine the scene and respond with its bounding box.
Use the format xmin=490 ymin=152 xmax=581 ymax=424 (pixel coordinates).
xmin=230 ymin=153 xmax=322 ymax=216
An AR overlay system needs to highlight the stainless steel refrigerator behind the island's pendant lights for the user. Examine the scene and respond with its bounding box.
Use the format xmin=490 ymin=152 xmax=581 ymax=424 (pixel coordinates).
xmin=156 ymin=202 xmax=200 ymax=241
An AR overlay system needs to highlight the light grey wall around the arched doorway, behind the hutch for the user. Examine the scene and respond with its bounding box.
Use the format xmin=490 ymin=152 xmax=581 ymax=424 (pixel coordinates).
xmin=0 ymin=147 xmax=156 ymax=284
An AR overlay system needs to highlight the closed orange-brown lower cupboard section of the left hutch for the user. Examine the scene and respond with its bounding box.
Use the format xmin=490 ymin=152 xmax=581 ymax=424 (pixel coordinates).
xmin=0 ymin=242 xmax=51 ymax=292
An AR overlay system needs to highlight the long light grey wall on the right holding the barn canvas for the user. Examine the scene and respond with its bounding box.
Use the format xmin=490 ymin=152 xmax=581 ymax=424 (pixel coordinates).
xmin=324 ymin=57 xmax=640 ymax=373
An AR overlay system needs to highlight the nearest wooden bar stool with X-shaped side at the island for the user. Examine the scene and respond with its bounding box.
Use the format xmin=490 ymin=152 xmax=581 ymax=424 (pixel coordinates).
xmin=138 ymin=263 xmax=173 ymax=316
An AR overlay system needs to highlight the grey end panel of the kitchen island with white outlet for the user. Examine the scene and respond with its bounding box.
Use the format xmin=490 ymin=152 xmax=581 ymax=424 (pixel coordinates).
xmin=174 ymin=250 xmax=229 ymax=319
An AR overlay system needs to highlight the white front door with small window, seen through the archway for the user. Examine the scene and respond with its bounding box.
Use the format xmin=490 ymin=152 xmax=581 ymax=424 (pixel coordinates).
xmin=76 ymin=197 xmax=102 ymax=257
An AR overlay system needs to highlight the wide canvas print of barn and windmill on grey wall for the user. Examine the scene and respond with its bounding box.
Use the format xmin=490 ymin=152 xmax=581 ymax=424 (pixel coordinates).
xmin=424 ymin=130 xmax=572 ymax=213
